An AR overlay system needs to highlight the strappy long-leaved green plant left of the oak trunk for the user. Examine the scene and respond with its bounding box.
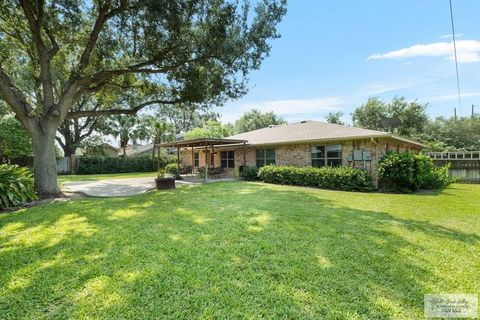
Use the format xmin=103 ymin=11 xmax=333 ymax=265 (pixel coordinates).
xmin=0 ymin=164 xmax=37 ymax=209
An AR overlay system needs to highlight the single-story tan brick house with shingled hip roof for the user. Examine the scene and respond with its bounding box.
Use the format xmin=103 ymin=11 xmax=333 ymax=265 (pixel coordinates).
xmin=175 ymin=121 xmax=428 ymax=176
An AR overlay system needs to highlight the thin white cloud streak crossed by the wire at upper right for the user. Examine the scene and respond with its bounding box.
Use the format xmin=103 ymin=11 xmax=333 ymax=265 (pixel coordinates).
xmin=368 ymin=40 xmax=480 ymax=63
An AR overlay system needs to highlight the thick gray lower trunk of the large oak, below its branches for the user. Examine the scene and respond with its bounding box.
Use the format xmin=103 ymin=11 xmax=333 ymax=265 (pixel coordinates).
xmin=32 ymin=129 xmax=60 ymax=198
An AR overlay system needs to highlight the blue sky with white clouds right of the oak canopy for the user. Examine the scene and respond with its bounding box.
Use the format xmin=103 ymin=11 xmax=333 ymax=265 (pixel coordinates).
xmin=217 ymin=0 xmax=480 ymax=122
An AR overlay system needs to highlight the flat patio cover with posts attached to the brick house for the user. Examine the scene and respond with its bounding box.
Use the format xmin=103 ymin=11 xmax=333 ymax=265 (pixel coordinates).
xmin=157 ymin=138 xmax=248 ymax=182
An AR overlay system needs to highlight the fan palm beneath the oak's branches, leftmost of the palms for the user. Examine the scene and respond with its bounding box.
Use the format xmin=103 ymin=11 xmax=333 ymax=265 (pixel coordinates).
xmin=109 ymin=115 xmax=148 ymax=157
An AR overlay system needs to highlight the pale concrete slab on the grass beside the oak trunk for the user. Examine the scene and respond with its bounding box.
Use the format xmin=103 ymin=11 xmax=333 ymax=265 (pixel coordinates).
xmin=61 ymin=177 xmax=155 ymax=197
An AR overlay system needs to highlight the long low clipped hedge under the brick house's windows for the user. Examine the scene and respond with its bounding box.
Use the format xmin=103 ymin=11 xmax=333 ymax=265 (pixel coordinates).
xmin=258 ymin=166 xmax=372 ymax=191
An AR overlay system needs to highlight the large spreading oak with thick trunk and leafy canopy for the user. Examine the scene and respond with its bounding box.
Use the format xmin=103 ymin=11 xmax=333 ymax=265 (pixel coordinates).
xmin=0 ymin=0 xmax=286 ymax=197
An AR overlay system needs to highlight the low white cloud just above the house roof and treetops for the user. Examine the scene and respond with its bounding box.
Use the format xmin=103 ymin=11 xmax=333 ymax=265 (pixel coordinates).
xmin=217 ymin=97 xmax=346 ymax=122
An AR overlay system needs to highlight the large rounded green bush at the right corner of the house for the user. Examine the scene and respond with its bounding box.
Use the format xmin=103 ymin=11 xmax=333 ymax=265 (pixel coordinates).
xmin=377 ymin=152 xmax=453 ymax=193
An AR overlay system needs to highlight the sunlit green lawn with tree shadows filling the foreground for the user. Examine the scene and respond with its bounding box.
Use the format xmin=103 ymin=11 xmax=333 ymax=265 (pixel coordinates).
xmin=0 ymin=182 xmax=480 ymax=319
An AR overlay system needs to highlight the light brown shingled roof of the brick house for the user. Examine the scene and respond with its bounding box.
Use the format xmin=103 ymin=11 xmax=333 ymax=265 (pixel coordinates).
xmin=228 ymin=121 xmax=428 ymax=148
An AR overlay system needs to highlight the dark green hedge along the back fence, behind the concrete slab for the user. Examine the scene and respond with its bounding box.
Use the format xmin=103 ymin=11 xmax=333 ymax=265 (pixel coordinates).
xmin=77 ymin=156 xmax=173 ymax=174
